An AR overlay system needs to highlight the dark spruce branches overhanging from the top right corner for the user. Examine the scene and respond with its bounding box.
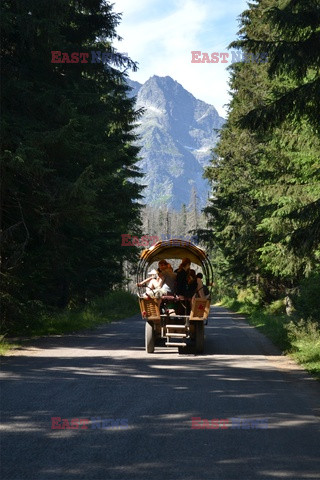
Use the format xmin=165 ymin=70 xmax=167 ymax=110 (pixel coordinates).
xmin=232 ymin=0 xmax=320 ymax=133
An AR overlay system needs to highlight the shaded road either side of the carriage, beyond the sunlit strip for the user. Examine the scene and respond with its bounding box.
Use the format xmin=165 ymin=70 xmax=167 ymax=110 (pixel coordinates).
xmin=5 ymin=307 xmax=281 ymax=356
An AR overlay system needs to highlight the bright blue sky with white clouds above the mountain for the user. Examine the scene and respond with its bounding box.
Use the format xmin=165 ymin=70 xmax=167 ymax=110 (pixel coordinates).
xmin=112 ymin=0 xmax=247 ymax=116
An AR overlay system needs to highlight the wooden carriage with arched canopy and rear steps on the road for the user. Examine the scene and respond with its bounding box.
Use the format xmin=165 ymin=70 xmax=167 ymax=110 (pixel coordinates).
xmin=137 ymin=239 xmax=213 ymax=353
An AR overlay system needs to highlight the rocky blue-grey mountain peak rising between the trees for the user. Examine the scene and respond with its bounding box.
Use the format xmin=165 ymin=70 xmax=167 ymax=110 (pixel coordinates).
xmin=130 ymin=75 xmax=224 ymax=209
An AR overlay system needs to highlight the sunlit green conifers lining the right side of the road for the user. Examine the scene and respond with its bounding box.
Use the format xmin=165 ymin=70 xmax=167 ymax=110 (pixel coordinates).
xmin=206 ymin=0 xmax=320 ymax=315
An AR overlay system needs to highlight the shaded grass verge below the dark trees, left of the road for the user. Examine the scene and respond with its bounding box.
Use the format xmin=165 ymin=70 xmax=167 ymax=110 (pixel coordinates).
xmin=0 ymin=290 xmax=139 ymax=355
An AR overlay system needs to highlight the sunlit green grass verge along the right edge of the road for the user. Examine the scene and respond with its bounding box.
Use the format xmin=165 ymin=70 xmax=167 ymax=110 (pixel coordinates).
xmin=221 ymin=297 xmax=320 ymax=380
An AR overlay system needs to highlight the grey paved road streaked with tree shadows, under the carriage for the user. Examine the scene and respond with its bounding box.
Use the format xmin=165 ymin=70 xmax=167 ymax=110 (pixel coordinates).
xmin=1 ymin=307 xmax=320 ymax=480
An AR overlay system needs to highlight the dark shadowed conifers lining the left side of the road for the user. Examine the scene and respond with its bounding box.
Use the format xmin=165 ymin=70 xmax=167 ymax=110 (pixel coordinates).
xmin=1 ymin=0 xmax=141 ymax=328
